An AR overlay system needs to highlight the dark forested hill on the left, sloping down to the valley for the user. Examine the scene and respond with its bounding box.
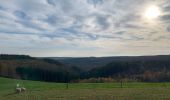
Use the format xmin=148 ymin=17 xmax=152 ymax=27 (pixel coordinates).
xmin=0 ymin=54 xmax=81 ymax=82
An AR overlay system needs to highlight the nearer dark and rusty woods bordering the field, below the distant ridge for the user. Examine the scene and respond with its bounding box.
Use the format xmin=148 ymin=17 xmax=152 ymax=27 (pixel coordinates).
xmin=0 ymin=55 xmax=170 ymax=82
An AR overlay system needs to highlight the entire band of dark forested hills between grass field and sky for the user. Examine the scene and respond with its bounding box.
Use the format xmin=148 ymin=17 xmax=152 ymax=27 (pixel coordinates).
xmin=0 ymin=55 xmax=170 ymax=82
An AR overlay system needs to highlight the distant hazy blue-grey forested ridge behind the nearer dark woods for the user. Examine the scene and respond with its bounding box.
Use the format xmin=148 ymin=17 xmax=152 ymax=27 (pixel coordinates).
xmin=48 ymin=55 xmax=170 ymax=70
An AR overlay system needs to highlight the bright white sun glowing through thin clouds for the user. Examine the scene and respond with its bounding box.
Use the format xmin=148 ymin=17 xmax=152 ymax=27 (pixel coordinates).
xmin=145 ymin=6 xmax=161 ymax=19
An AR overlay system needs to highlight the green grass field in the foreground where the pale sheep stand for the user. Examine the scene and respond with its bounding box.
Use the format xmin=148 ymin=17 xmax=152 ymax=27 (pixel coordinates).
xmin=0 ymin=78 xmax=170 ymax=100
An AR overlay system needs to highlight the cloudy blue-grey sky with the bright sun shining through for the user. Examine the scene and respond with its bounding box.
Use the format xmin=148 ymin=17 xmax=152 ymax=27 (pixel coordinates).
xmin=0 ymin=0 xmax=170 ymax=57
